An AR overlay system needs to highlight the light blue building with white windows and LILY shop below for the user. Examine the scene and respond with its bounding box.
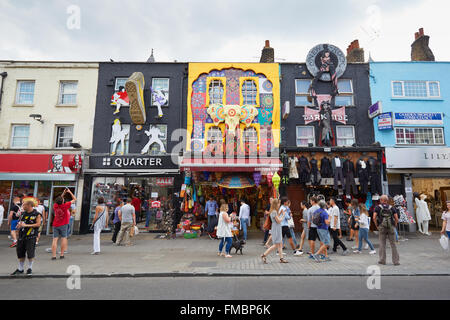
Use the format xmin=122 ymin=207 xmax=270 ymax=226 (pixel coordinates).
xmin=369 ymin=61 xmax=450 ymax=227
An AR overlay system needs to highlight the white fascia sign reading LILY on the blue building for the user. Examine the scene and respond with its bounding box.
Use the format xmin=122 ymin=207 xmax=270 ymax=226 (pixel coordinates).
xmin=386 ymin=147 xmax=450 ymax=169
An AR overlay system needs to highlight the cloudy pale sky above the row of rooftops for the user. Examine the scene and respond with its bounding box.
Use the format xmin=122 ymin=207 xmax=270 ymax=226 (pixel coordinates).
xmin=0 ymin=0 xmax=450 ymax=62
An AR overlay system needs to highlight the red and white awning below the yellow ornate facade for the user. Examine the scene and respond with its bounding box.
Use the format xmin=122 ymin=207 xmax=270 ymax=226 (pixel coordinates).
xmin=180 ymin=158 xmax=283 ymax=172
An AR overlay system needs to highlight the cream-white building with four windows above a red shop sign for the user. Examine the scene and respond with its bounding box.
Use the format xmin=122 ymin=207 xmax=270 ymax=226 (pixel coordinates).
xmin=0 ymin=61 xmax=98 ymax=233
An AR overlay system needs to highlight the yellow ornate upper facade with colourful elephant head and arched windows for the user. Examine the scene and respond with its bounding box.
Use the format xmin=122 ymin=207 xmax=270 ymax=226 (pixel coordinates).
xmin=186 ymin=63 xmax=280 ymax=158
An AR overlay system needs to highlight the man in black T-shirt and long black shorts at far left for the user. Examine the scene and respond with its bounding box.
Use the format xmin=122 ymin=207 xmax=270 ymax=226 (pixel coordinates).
xmin=11 ymin=200 xmax=42 ymax=276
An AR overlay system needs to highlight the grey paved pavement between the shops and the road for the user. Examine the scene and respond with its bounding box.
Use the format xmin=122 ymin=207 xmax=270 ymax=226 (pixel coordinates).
xmin=0 ymin=232 xmax=450 ymax=279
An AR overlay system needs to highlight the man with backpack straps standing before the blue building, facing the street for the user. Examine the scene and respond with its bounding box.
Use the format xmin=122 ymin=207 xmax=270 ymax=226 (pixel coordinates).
xmin=373 ymin=195 xmax=400 ymax=266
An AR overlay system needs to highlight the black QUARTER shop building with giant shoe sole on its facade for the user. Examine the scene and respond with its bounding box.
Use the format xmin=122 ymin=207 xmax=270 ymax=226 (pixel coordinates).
xmin=80 ymin=63 xmax=187 ymax=233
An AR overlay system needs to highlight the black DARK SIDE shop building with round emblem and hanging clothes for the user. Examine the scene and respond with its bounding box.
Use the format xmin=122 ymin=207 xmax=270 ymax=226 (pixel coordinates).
xmin=280 ymin=44 xmax=385 ymax=225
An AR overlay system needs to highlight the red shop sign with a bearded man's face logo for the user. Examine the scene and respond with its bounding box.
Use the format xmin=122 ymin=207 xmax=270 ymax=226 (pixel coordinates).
xmin=0 ymin=153 xmax=82 ymax=173
